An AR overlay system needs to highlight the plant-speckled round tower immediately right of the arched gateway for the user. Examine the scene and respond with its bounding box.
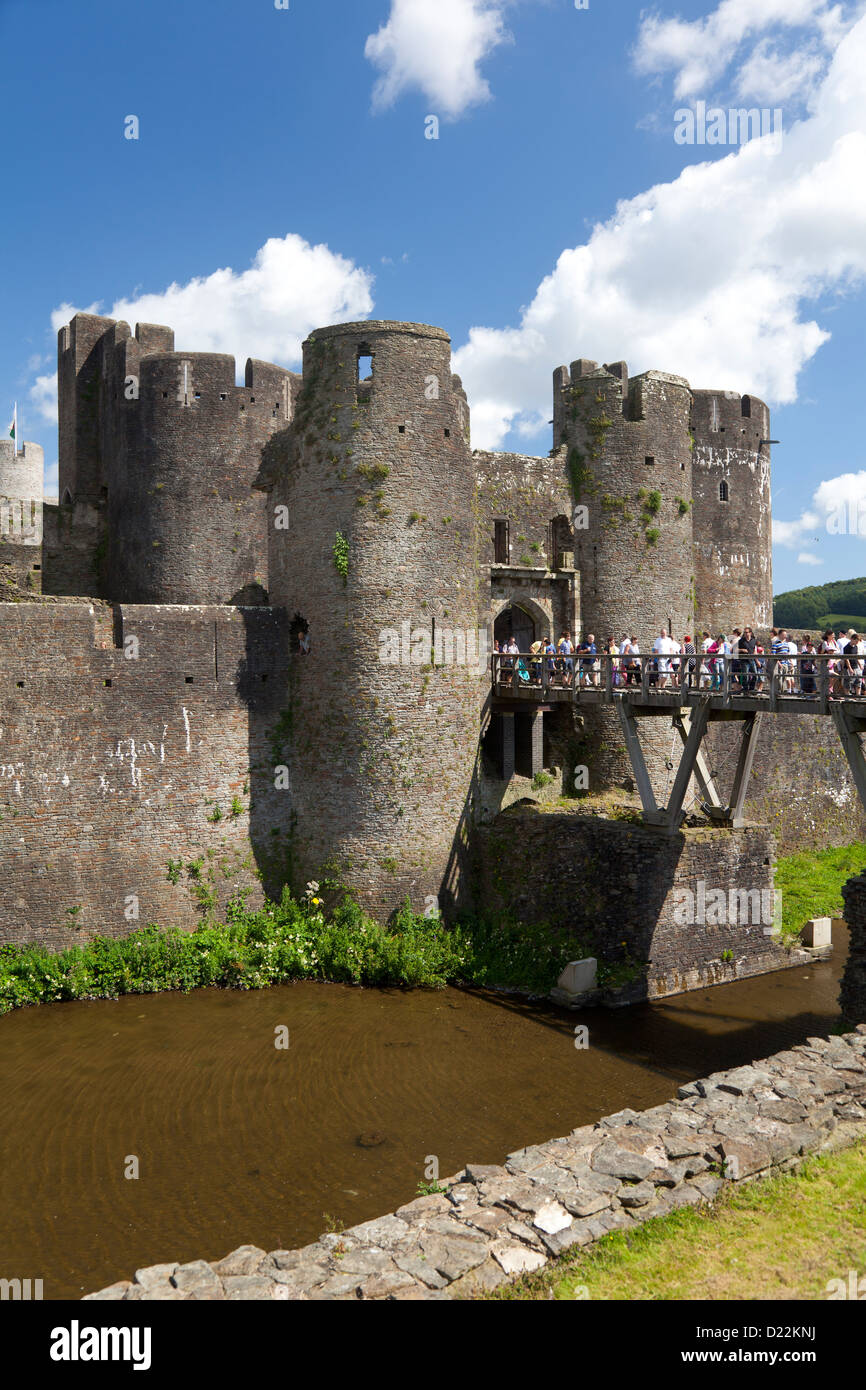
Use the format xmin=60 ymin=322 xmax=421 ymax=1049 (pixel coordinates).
xmin=553 ymin=360 xmax=695 ymax=794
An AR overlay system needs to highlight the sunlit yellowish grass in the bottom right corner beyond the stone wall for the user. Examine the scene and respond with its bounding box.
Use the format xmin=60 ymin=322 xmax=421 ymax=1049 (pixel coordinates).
xmin=488 ymin=1144 xmax=866 ymax=1301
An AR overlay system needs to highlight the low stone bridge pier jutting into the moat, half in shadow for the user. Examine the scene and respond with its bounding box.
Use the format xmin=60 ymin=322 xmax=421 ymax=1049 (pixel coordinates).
xmin=478 ymin=808 xmax=792 ymax=998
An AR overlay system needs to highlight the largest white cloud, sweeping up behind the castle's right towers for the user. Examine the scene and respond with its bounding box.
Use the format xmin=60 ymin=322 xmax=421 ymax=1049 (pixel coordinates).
xmin=455 ymin=17 xmax=866 ymax=448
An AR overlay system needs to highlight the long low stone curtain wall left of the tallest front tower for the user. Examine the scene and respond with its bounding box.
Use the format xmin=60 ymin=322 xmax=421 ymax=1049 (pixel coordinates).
xmin=0 ymin=603 xmax=289 ymax=949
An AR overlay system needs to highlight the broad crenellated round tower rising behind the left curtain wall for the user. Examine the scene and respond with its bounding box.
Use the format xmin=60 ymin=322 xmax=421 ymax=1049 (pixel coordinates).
xmin=107 ymin=352 xmax=291 ymax=603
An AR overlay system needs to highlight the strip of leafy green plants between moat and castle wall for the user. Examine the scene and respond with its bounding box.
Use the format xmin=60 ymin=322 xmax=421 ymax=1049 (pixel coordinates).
xmin=0 ymin=891 xmax=617 ymax=1013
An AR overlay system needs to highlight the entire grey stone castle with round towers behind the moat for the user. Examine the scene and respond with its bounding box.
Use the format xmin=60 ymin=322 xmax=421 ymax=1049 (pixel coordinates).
xmin=0 ymin=314 xmax=856 ymax=995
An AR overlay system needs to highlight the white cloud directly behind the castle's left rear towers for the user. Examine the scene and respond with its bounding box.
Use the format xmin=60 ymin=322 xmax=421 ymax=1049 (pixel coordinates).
xmin=31 ymin=234 xmax=373 ymax=421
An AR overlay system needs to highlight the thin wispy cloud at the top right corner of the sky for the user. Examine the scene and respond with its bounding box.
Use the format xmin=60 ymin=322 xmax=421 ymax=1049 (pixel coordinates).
xmin=634 ymin=0 xmax=862 ymax=106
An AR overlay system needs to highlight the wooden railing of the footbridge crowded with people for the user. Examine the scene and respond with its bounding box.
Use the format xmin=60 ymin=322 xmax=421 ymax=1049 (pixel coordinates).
xmin=491 ymin=652 xmax=866 ymax=713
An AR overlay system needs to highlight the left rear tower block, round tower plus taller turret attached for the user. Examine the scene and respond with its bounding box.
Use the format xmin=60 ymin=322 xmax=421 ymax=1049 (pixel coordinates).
xmin=50 ymin=314 xmax=297 ymax=603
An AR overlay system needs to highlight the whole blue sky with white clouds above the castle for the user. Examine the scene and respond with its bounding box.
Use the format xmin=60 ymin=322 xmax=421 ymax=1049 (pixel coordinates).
xmin=0 ymin=0 xmax=866 ymax=592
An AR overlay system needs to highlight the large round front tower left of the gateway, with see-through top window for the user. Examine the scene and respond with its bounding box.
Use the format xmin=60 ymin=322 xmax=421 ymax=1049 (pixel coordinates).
xmin=263 ymin=322 xmax=480 ymax=917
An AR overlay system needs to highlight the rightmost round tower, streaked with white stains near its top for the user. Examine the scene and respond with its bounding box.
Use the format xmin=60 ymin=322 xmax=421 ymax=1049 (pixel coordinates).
xmin=691 ymin=391 xmax=773 ymax=635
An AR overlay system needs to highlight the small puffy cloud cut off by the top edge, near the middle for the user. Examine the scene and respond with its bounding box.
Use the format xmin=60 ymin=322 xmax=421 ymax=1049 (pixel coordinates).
xmin=364 ymin=0 xmax=507 ymax=120
